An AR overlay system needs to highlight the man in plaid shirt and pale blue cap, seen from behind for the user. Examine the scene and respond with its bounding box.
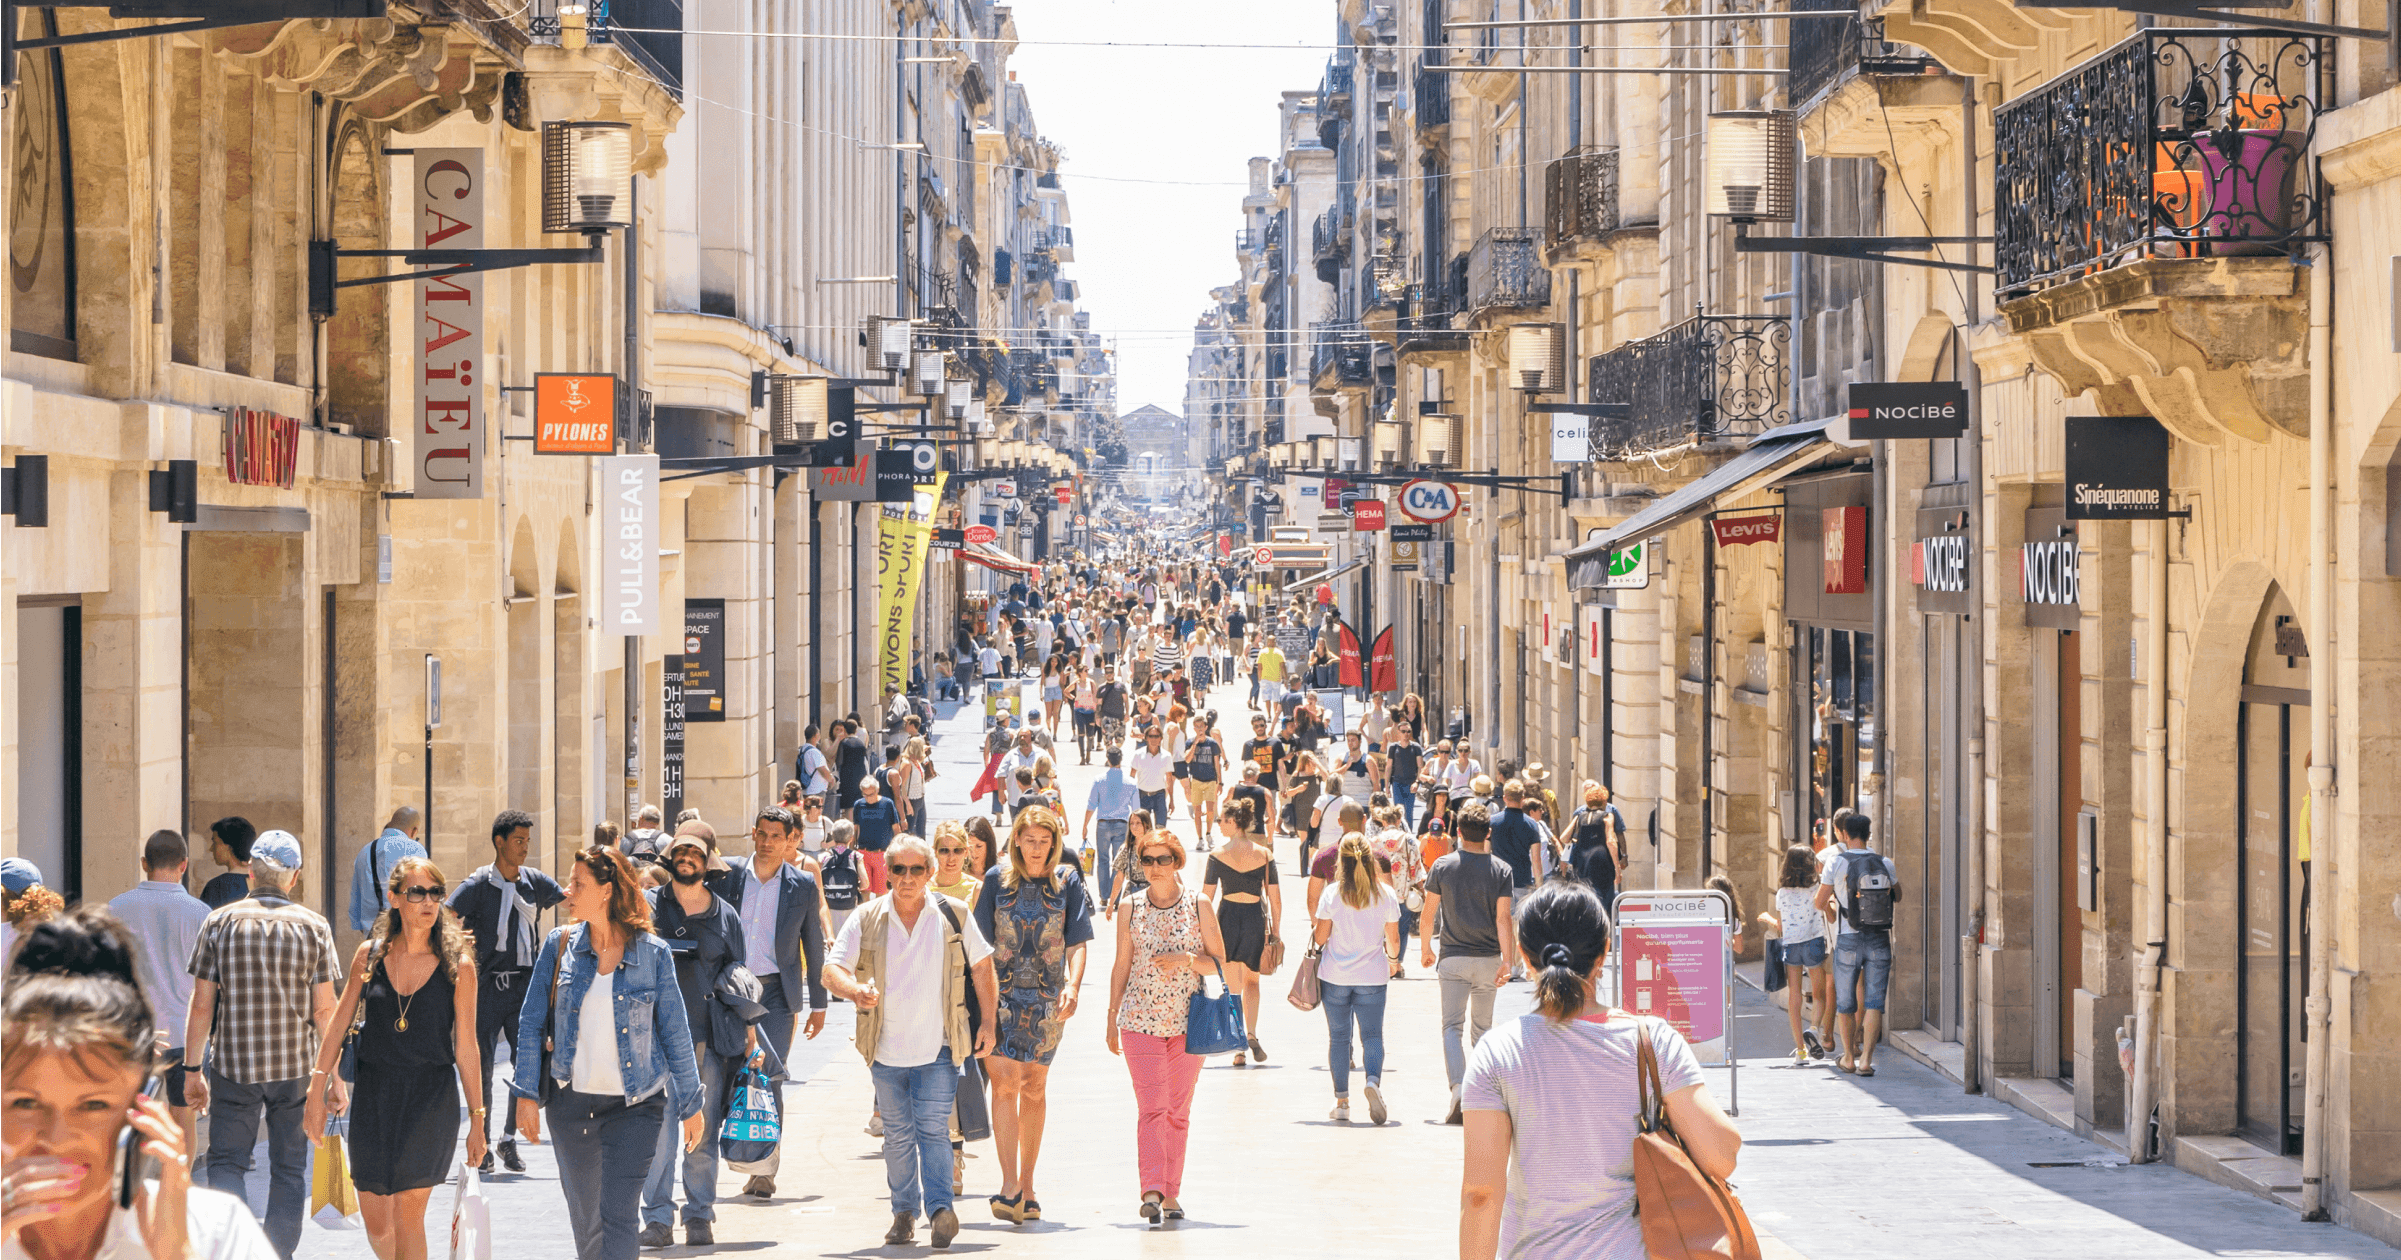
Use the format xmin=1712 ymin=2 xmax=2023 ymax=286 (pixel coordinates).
xmin=182 ymin=830 xmax=348 ymax=1260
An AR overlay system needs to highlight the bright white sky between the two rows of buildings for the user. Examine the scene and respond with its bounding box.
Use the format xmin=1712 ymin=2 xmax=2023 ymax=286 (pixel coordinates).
xmin=1008 ymin=0 xmax=1335 ymax=415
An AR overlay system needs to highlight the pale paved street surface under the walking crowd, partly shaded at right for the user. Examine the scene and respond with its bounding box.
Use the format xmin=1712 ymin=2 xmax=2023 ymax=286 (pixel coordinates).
xmin=255 ymin=672 xmax=2401 ymax=1260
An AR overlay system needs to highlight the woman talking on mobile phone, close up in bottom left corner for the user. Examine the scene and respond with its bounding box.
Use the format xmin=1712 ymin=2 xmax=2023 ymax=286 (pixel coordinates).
xmin=0 ymin=905 xmax=276 ymax=1260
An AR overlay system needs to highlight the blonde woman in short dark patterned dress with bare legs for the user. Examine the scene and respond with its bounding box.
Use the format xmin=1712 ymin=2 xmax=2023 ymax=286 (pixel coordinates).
xmin=975 ymin=806 xmax=1092 ymax=1224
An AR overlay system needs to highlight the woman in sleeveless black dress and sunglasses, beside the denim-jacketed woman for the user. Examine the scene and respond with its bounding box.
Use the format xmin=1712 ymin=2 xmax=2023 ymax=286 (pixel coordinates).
xmin=305 ymin=857 xmax=485 ymax=1260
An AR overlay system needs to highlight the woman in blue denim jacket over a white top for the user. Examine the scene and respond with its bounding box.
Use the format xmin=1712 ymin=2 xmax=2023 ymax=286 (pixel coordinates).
xmin=511 ymin=847 xmax=708 ymax=1260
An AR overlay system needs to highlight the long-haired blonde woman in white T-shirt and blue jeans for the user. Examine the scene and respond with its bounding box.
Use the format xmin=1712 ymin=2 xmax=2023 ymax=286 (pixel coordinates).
xmin=1316 ymin=830 xmax=1400 ymax=1123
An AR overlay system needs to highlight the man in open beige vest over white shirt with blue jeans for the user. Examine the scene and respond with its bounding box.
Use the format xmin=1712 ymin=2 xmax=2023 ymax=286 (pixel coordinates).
xmin=826 ymin=835 xmax=999 ymax=1248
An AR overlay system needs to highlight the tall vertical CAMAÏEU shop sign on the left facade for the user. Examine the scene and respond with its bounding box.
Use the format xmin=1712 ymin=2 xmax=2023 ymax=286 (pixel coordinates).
xmin=411 ymin=149 xmax=485 ymax=499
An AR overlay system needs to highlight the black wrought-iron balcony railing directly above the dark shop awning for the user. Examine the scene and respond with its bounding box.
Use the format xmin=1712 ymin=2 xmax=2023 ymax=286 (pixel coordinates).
xmin=1589 ymin=314 xmax=1794 ymax=461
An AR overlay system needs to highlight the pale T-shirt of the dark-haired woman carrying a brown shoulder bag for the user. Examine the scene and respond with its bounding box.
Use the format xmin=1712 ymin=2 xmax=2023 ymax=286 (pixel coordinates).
xmin=1460 ymin=1013 xmax=1702 ymax=1260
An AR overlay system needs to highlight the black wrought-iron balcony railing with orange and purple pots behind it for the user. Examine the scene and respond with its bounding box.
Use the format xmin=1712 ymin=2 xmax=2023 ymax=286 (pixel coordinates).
xmin=1993 ymin=26 xmax=2334 ymax=298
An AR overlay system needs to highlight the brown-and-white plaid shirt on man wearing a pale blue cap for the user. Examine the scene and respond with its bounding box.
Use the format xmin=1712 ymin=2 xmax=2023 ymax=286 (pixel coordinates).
xmin=192 ymin=898 xmax=341 ymax=1085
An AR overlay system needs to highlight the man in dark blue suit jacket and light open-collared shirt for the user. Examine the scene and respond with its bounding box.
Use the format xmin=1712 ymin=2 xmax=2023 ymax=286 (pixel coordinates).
xmin=718 ymin=804 xmax=826 ymax=1198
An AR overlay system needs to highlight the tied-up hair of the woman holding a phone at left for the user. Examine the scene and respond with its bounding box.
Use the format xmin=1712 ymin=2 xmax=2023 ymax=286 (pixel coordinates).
xmin=0 ymin=905 xmax=158 ymax=1078
